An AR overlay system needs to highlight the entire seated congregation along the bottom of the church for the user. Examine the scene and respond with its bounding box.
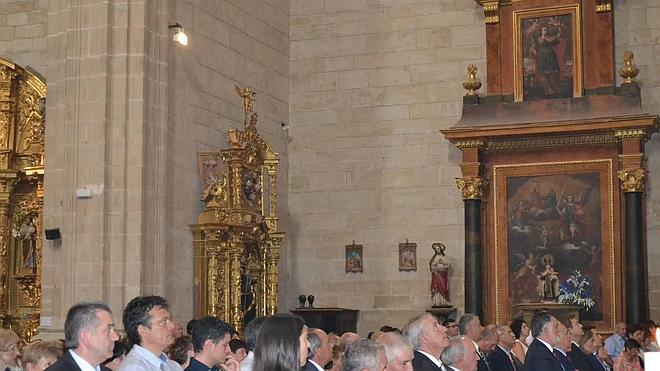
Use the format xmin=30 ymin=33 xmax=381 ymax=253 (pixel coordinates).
xmin=0 ymin=296 xmax=660 ymax=371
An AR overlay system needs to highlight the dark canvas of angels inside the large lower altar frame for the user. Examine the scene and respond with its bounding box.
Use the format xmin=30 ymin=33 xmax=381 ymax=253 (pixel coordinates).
xmin=506 ymin=172 xmax=603 ymax=321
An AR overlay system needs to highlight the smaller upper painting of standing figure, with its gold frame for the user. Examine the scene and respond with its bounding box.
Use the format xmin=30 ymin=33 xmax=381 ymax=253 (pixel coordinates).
xmin=513 ymin=4 xmax=582 ymax=102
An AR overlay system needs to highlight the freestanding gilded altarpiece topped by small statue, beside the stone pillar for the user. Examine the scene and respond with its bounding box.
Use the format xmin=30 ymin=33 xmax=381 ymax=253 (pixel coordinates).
xmin=191 ymin=87 xmax=284 ymax=331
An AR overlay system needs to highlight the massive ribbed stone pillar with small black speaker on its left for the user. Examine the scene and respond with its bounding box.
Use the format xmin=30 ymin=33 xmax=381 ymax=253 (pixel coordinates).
xmin=41 ymin=0 xmax=168 ymax=337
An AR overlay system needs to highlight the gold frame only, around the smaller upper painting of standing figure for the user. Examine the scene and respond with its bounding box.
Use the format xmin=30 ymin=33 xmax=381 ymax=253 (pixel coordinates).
xmin=513 ymin=4 xmax=582 ymax=102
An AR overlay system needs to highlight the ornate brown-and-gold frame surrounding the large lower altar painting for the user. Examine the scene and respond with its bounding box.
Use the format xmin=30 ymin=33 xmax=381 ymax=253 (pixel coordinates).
xmin=492 ymin=159 xmax=621 ymax=331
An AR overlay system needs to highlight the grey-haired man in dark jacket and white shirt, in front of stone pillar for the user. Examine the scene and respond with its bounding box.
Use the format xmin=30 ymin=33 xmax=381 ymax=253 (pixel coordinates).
xmin=47 ymin=302 xmax=119 ymax=371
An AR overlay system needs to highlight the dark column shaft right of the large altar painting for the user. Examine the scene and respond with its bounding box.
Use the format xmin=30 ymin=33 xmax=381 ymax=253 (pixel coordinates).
xmin=623 ymin=192 xmax=649 ymax=323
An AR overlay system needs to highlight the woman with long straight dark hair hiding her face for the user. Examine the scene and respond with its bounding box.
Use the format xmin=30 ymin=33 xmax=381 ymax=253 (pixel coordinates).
xmin=253 ymin=314 xmax=308 ymax=371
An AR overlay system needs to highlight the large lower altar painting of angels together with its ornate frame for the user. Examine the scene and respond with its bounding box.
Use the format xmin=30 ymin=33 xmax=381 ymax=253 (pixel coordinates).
xmin=492 ymin=159 xmax=620 ymax=329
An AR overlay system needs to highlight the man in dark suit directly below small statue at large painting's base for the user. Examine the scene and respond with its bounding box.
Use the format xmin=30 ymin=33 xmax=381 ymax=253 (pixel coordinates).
xmin=523 ymin=312 xmax=564 ymax=371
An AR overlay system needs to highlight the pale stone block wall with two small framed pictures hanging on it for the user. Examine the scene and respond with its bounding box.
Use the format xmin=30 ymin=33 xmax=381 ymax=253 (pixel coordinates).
xmin=288 ymin=0 xmax=485 ymax=335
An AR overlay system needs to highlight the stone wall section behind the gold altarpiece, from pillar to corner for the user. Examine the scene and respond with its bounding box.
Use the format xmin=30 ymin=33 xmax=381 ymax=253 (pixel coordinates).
xmin=165 ymin=0 xmax=289 ymax=321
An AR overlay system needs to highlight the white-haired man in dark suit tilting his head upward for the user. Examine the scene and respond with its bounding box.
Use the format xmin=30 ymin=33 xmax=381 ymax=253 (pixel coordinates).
xmin=403 ymin=313 xmax=449 ymax=371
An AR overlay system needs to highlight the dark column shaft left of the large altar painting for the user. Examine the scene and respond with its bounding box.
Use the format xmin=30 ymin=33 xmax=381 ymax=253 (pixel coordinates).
xmin=464 ymin=199 xmax=484 ymax=321
